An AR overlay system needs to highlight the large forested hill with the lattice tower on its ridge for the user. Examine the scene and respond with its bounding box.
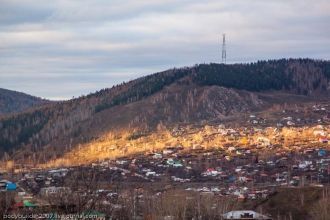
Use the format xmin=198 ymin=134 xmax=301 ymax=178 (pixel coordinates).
xmin=0 ymin=59 xmax=330 ymax=161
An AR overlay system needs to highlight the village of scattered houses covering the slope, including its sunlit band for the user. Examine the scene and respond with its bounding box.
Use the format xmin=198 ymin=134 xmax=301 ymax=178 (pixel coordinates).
xmin=1 ymin=103 xmax=330 ymax=216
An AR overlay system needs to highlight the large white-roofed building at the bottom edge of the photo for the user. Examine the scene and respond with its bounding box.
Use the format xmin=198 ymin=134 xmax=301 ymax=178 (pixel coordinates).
xmin=223 ymin=210 xmax=272 ymax=220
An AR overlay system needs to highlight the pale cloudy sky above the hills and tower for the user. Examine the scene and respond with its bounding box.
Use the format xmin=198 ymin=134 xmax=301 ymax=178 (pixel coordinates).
xmin=0 ymin=0 xmax=330 ymax=99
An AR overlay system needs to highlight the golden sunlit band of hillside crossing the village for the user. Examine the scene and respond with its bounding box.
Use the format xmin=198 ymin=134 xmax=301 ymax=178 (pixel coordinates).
xmin=41 ymin=126 xmax=330 ymax=167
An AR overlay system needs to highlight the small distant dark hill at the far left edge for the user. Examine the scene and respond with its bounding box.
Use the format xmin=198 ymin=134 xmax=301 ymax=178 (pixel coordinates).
xmin=0 ymin=88 xmax=48 ymax=116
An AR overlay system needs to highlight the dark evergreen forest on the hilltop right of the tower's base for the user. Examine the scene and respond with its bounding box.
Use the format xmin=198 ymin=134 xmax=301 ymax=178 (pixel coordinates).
xmin=193 ymin=59 xmax=330 ymax=95
